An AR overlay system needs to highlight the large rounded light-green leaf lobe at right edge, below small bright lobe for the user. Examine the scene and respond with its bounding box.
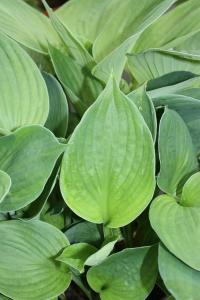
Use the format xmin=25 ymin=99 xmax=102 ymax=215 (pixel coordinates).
xmin=150 ymin=195 xmax=200 ymax=271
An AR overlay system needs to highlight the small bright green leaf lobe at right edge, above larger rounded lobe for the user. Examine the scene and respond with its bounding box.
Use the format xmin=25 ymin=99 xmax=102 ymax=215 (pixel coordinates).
xmin=180 ymin=172 xmax=200 ymax=207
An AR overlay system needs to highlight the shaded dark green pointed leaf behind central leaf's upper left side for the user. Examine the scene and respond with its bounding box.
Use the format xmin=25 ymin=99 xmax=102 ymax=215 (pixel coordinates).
xmin=49 ymin=46 xmax=103 ymax=115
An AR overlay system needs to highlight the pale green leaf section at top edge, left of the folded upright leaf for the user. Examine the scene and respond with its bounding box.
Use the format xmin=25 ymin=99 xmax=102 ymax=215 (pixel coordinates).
xmin=56 ymin=0 xmax=108 ymax=43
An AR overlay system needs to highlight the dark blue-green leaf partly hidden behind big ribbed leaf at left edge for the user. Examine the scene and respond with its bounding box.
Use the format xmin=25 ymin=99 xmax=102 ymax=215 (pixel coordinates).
xmin=43 ymin=73 xmax=69 ymax=137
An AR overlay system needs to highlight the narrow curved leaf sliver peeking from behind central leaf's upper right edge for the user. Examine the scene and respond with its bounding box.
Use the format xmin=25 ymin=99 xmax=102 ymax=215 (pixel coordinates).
xmin=128 ymin=86 xmax=157 ymax=142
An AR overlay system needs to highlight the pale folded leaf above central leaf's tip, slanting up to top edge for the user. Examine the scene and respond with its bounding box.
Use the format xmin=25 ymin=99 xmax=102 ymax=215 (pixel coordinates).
xmin=93 ymin=0 xmax=175 ymax=62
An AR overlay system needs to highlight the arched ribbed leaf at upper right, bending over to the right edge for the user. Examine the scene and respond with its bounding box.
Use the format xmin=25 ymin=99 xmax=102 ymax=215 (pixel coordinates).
xmin=128 ymin=49 xmax=200 ymax=84
